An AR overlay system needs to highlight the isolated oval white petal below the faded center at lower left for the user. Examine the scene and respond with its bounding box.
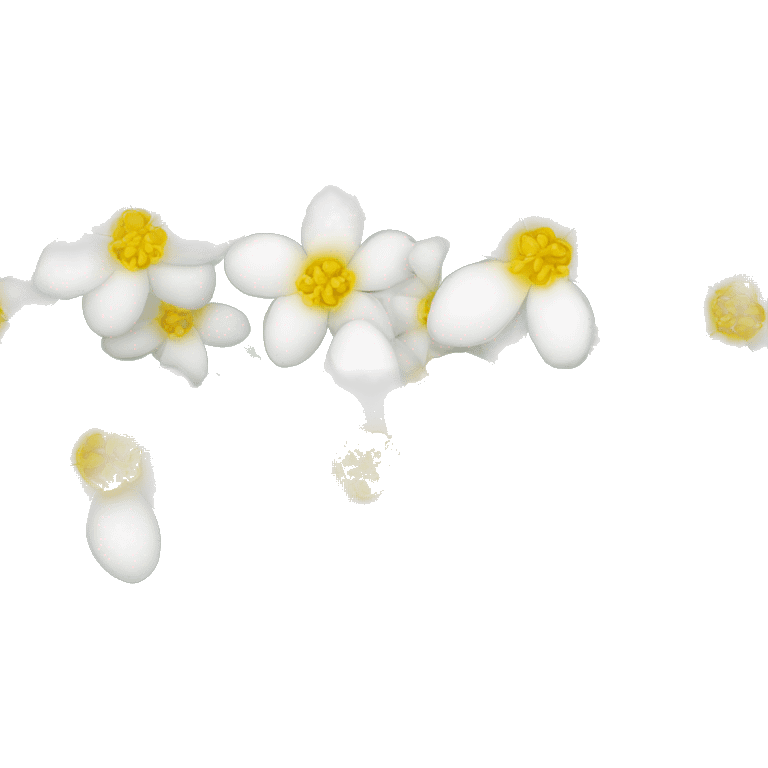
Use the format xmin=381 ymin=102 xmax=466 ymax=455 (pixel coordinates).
xmin=85 ymin=483 xmax=160 ymax=584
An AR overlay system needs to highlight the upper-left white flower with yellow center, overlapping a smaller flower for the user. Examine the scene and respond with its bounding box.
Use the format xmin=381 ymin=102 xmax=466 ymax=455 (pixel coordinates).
xmin=32 ymin=208 xmax=228 ymax=336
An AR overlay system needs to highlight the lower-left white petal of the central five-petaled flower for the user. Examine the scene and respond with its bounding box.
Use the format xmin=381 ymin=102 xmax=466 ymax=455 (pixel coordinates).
xmin=264 ymin=293 xmax=328 ymax=368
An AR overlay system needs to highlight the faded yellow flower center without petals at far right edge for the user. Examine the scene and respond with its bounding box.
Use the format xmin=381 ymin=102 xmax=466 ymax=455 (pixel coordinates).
xmin=704 ymin=275 xmax=768 ymax=349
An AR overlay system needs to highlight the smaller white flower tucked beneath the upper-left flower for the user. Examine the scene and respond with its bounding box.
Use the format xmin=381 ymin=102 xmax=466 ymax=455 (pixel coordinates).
xmin=101 ymin=292 xmax=251 ymax=387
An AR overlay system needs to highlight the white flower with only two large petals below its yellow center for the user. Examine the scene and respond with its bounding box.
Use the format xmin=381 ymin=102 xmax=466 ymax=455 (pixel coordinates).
xmin=427 ymin=217 xmax=597 ymax=368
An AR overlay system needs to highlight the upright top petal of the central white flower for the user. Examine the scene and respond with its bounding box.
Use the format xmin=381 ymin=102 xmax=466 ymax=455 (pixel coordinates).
xmin=301 ymin=186 xmax=365 ymax=261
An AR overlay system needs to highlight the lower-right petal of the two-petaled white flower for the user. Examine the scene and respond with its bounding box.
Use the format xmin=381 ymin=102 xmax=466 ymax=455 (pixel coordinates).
xmin=527 ymin=280 xmax=596 ymax=368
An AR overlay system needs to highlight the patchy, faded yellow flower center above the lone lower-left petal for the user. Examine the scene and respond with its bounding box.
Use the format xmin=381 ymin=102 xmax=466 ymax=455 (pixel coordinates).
xmin=75 ymin=432 xmax=141 ymax=490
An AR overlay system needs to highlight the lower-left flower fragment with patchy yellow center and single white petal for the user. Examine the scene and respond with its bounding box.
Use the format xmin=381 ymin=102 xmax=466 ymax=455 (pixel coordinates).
xmin=71 ymin=429 xmax=160 ymax=584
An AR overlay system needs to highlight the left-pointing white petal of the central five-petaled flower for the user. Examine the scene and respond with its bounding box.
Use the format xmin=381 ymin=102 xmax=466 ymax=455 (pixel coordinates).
xmin=224 ymin=233 xmax=307 ymax=299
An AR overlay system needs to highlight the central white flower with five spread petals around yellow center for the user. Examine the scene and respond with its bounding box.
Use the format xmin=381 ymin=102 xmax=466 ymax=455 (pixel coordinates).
xmin=224 ymin=186 xmax=414 ymax=367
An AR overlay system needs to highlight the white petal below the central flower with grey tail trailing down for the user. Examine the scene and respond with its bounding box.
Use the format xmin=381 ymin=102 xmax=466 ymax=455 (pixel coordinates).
xmin=325 ymin=320 xmax=402 ymax=422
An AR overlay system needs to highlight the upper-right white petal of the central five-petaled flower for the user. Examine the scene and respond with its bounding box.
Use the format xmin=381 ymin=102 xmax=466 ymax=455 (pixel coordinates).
xmin=347 ymin=229 xmax=415 ymax=291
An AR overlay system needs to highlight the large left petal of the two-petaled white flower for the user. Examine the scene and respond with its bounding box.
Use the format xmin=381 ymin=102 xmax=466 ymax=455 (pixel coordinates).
xmin=427 ymin=259 xmax=528 ymax=347
